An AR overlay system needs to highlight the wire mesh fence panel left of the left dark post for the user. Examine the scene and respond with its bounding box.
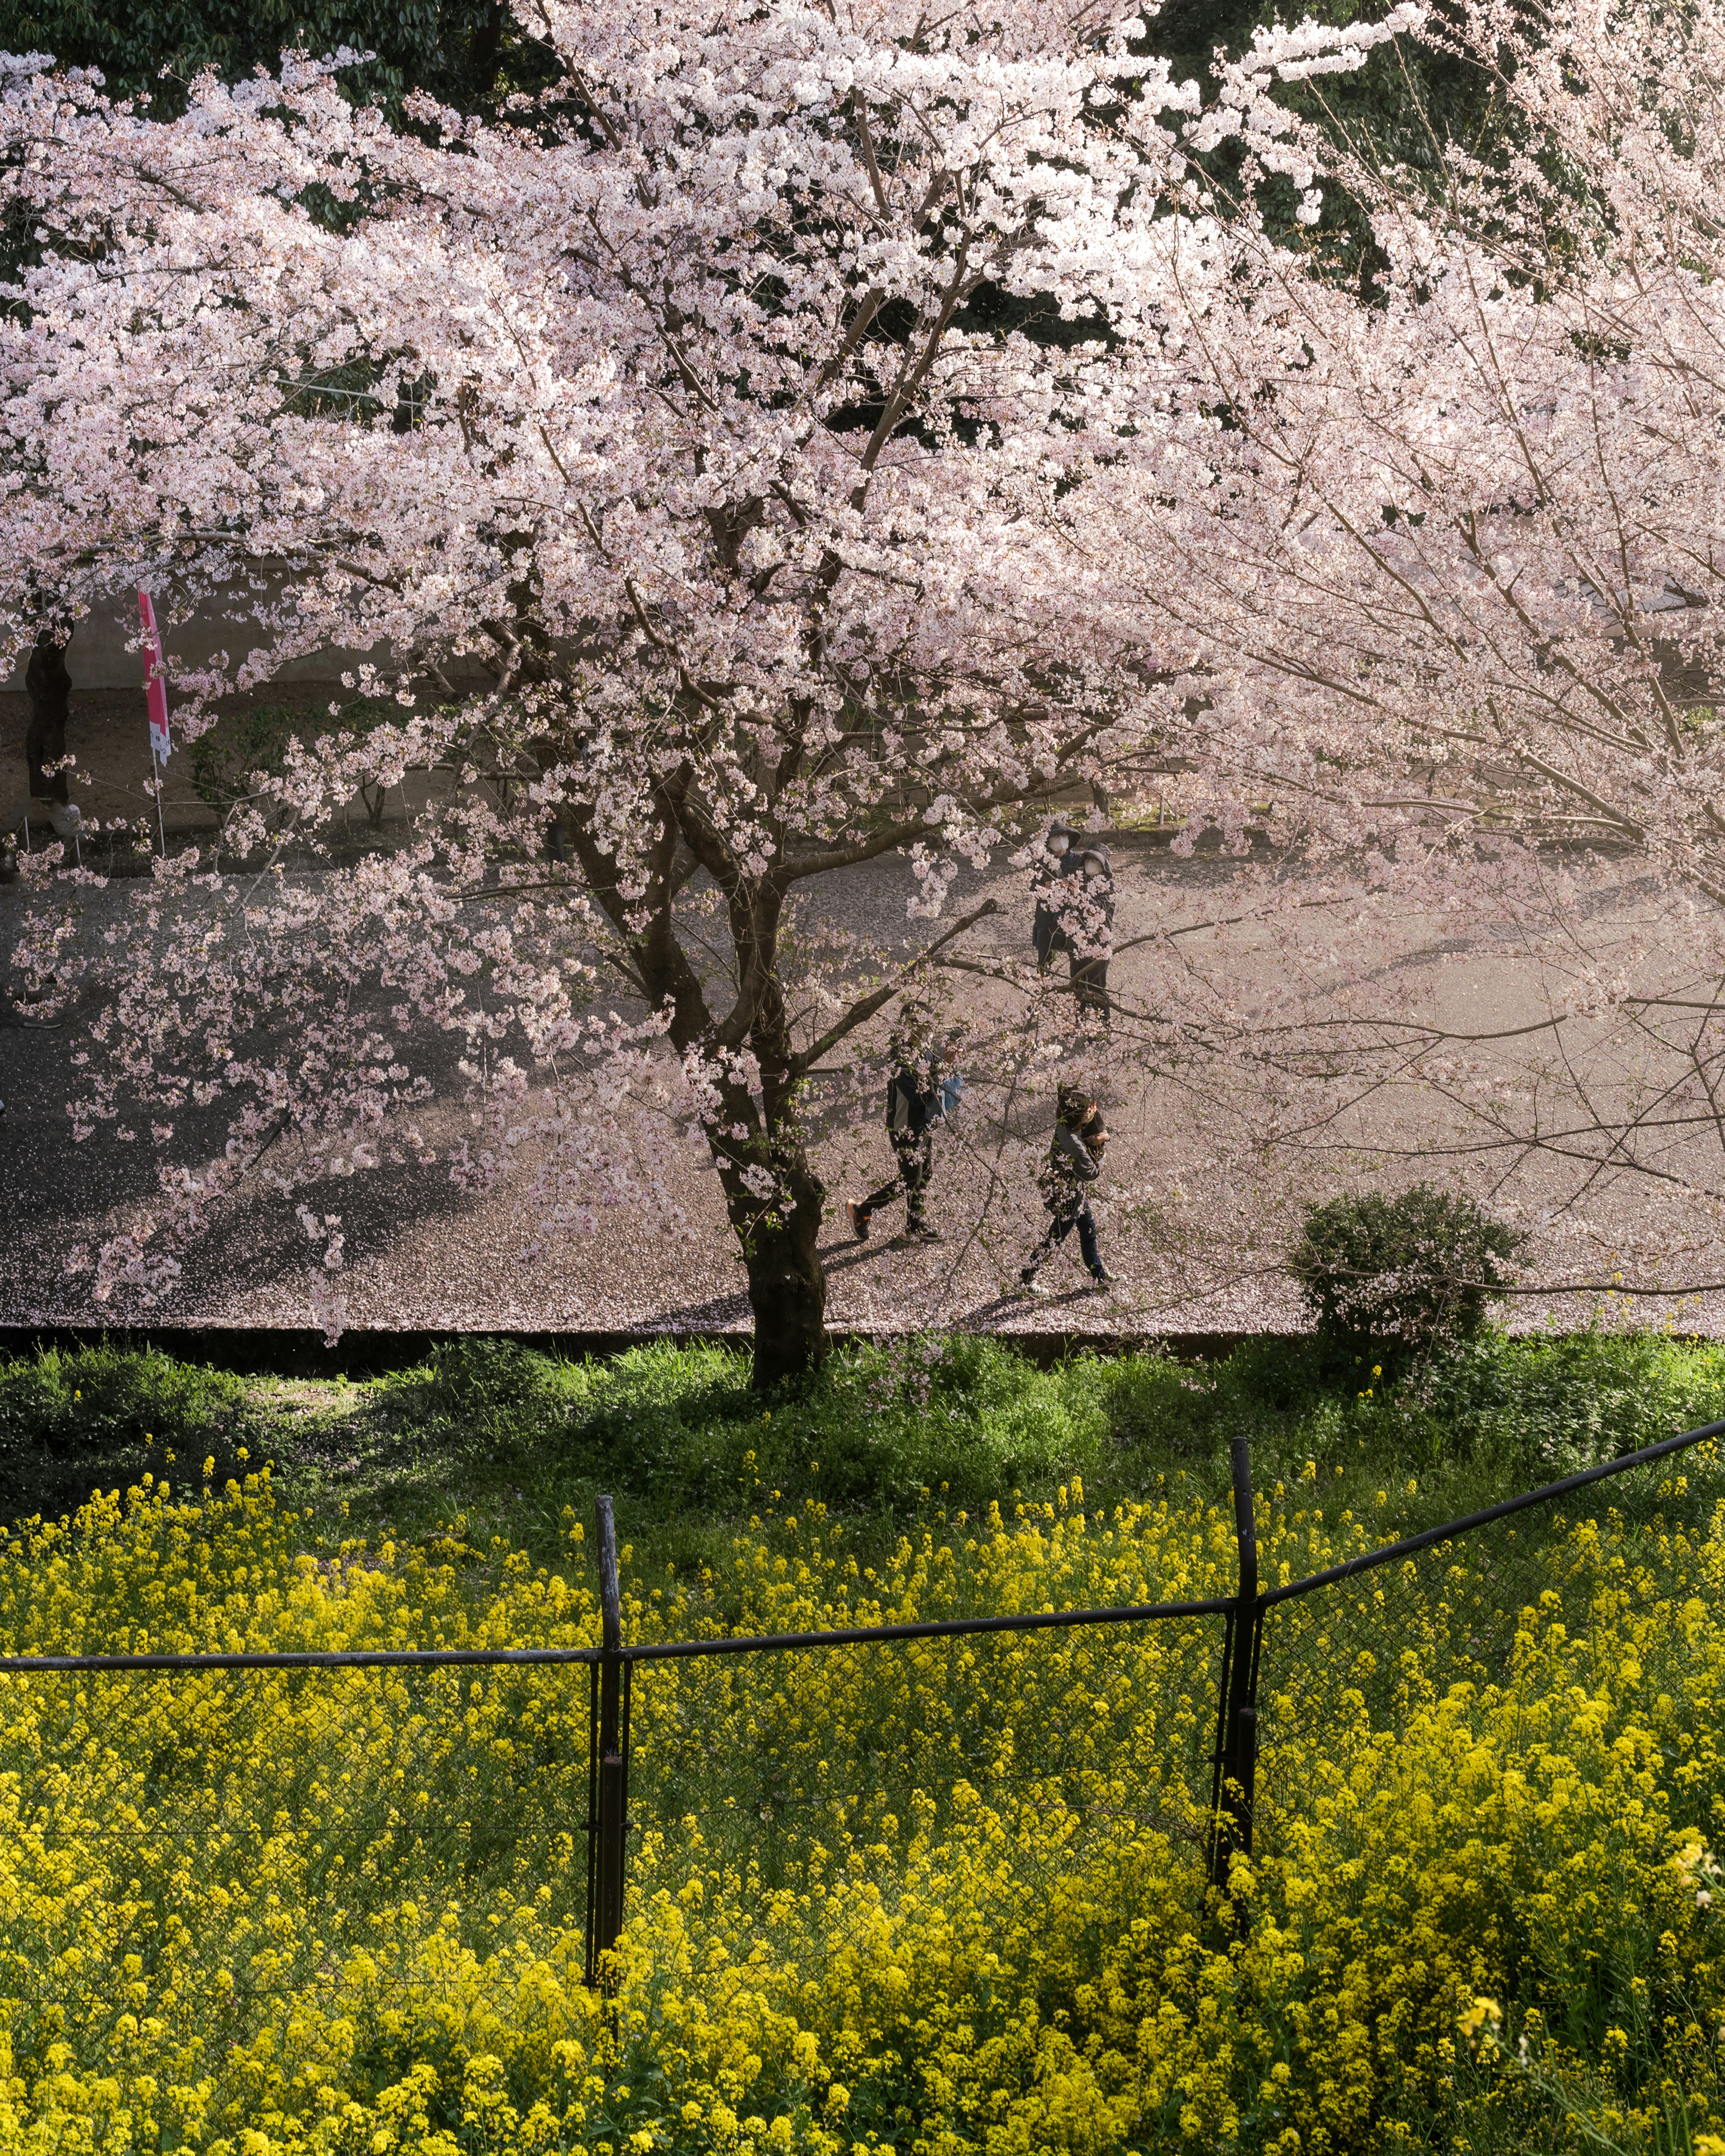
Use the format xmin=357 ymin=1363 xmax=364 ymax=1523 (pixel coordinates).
xmin=0 ymin=1665 xmax=588 ymax=2031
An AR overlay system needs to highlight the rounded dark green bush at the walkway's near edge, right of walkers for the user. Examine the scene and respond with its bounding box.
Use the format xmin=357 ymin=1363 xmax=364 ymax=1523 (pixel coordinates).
xmin=1289 ymin=1184 xmax=1526 ymax=1354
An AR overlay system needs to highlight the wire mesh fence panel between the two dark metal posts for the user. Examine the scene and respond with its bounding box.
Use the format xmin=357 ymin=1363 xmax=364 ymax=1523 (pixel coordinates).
xmin=630 ymin=1604 xmax=1225 ymax=1900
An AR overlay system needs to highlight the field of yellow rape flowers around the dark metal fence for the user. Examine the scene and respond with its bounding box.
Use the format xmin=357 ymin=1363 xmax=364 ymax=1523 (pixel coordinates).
xmin=0 ymin=1460 xmax=1725 ymax=2156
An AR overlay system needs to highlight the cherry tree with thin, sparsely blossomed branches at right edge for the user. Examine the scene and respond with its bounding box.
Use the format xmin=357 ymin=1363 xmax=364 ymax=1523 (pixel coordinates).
xmin=1044 ymin=0 xmax=1725 ymax=1259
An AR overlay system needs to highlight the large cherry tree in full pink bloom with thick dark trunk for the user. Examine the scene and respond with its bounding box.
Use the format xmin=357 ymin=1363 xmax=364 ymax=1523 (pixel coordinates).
xmin=0 ymin=0 xmax=1432 ymax=1382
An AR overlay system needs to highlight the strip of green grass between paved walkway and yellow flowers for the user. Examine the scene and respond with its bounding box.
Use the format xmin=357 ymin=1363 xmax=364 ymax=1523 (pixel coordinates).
xmin=0 ymin=1334 xmax=1725 ymax=1595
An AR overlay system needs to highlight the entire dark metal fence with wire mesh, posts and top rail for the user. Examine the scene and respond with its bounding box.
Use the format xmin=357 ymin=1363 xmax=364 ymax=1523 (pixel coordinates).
xmin=0 ymin=1425 xmax=1725 ymax=2044
